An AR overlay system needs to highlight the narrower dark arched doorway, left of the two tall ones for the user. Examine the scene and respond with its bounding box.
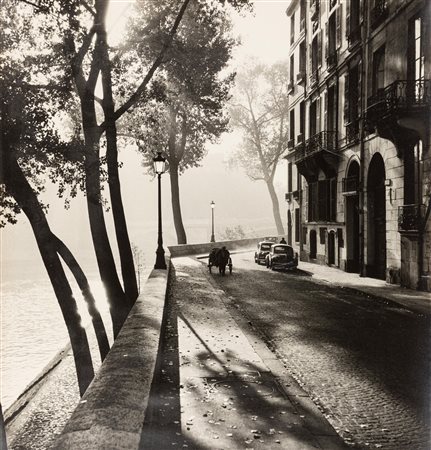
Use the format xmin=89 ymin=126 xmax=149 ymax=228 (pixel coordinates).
xmin=344 ymin=161 xmax=360 ymax=273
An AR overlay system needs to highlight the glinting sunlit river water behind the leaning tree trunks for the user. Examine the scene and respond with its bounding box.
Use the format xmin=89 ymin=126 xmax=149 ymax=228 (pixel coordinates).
xmin=0 ymin=264 xmax=149 ymax=410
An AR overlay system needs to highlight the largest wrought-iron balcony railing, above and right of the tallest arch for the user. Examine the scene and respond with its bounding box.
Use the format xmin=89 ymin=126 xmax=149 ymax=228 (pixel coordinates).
xmin=367 ymin=80 xmax=431 ymax=119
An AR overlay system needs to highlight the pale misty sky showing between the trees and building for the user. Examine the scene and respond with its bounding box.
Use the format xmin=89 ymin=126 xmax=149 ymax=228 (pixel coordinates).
xmin=1 ymin=0 xmax=290 ymax=272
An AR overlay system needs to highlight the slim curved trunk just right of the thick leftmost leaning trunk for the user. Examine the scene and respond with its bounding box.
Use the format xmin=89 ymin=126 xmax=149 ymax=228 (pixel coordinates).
xmin=52 ymin=234 xmax=109 ymax=361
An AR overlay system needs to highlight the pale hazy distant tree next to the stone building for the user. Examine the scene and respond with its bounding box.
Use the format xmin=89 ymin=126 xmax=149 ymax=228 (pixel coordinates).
xmin=230 ymin=63 xmax=289 ymax=235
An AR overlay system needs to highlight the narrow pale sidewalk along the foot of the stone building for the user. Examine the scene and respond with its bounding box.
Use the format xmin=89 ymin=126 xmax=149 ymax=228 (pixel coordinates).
xmin=298 ymin=261 xmax=431 ymax=315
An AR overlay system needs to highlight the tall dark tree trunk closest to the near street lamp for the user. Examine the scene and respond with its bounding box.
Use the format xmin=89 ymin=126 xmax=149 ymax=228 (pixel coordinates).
xmin=99 ymin=31 xmax=138 ymax=304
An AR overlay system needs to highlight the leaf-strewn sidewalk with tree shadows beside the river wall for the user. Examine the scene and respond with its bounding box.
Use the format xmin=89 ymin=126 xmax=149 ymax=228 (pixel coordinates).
xmin=140 ymin=257 xmax=346 ymax=450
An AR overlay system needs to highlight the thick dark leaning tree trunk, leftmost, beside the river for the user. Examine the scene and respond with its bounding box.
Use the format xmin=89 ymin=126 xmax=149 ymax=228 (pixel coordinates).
xmin=2 ymin=150 xmax=94 ymax=395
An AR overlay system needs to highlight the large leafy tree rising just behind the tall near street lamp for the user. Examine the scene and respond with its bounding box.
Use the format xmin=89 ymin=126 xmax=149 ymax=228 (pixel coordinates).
xmin=128 ymin=2 xmax=241 ymax=244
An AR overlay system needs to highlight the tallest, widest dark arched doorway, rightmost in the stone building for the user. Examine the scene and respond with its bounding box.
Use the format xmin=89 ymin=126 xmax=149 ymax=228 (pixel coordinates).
xmin=367 ymin=153 xmax=386 ymax=280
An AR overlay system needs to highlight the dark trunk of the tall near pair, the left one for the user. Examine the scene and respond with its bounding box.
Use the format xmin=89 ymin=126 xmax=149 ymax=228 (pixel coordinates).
xmin=81 ymin=96 xmax=133 ymax=338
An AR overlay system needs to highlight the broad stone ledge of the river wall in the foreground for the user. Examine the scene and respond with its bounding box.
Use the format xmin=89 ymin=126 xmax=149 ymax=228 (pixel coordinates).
xmin=52 ymin=258 xmax=170 ymax=450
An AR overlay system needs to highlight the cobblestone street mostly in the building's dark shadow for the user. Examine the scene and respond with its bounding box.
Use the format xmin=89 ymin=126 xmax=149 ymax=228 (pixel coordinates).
xmin=211 ymin=253 xmax=430 ymax=450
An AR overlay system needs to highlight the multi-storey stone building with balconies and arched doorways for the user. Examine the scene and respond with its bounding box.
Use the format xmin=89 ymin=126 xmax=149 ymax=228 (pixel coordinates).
xmin=285 ymin=0 xmax=431 ymax=290
